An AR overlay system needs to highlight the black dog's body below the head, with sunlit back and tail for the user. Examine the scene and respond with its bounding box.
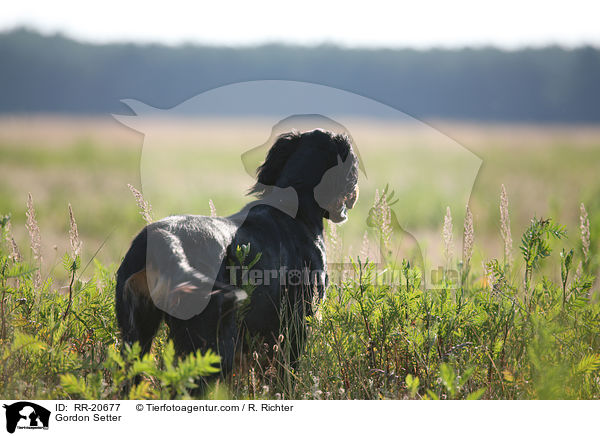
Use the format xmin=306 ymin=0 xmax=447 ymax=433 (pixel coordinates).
xmin=116 ymin=205 xmax=327 ymax=371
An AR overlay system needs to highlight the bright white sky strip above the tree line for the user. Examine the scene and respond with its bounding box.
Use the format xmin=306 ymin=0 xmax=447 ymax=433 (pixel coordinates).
xmin=0 ymin=0 xmax=600 ymax=48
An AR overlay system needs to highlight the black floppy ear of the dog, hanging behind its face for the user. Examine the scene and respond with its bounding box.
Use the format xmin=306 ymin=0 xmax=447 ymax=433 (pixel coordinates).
xmin=249 ymin=132 xmax=300 ymax=197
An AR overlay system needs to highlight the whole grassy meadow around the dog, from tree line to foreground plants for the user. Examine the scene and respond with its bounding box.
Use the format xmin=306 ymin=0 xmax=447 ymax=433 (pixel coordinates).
xmin=0 ymin=117 xmax=600 ymax=399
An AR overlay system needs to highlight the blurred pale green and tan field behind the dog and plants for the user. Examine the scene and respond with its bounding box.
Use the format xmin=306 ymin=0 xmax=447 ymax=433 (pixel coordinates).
xmin=0 ymin=117 xmax=600 ymax=280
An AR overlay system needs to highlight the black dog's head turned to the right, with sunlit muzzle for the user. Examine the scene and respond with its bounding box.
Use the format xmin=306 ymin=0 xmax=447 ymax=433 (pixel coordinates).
xmin=250 ymin=129 xmax=358 ymax=223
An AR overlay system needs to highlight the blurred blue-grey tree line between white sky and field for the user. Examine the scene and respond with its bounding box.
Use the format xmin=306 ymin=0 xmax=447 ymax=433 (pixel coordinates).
xmin=0 ymin=29 xmax=600 ymax=122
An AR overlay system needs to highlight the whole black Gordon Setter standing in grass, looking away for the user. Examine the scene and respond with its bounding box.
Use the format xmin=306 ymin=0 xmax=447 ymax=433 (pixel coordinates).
xmin=116 ymin=129 xmax=358 ymax=373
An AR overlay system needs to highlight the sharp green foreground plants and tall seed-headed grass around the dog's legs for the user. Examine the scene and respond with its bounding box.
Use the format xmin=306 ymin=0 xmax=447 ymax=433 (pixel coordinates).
xmin=0 ymin=187 xmax=600 ymax=399
